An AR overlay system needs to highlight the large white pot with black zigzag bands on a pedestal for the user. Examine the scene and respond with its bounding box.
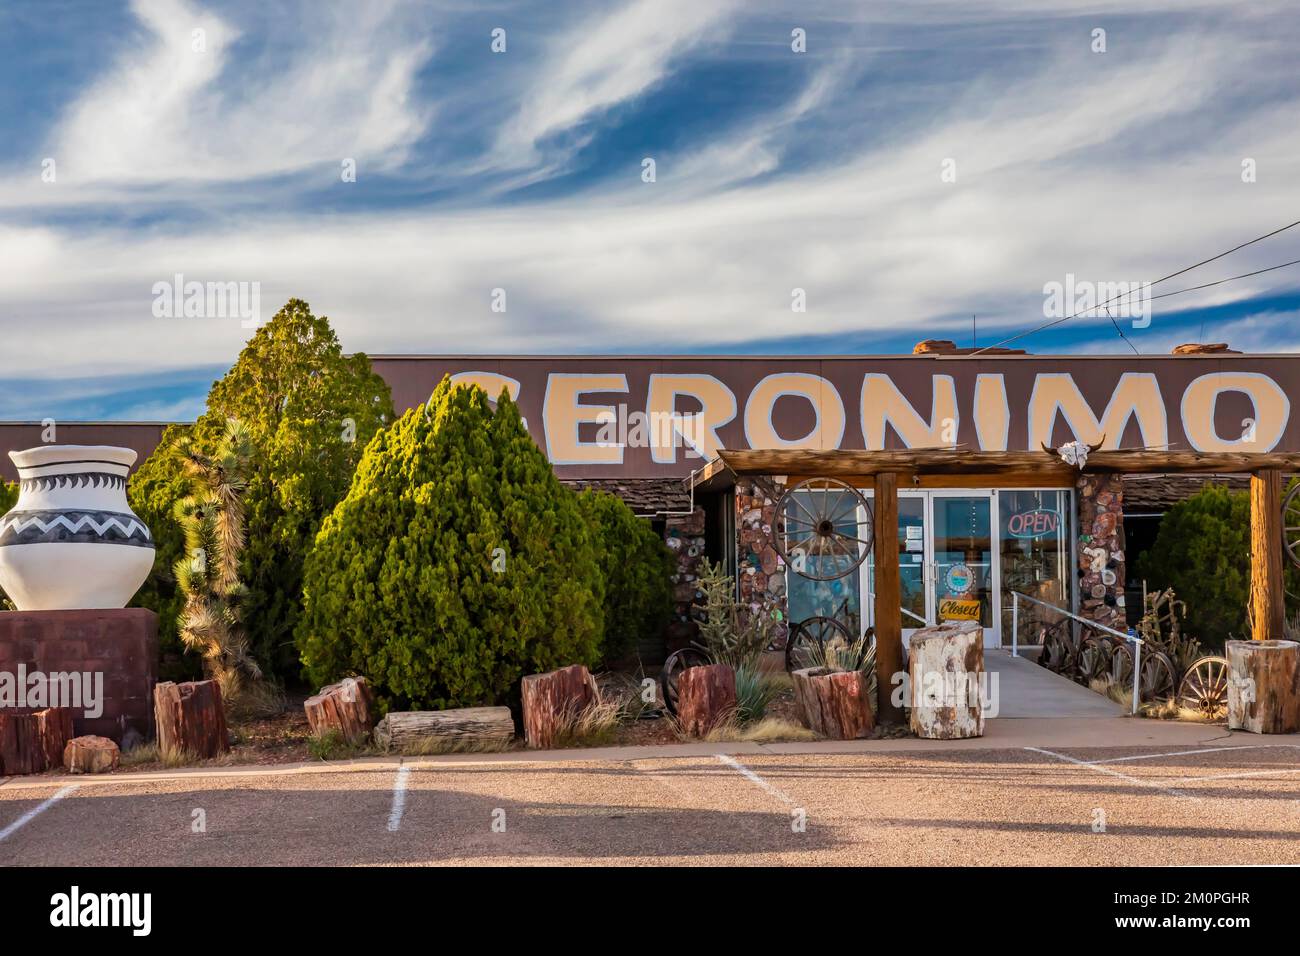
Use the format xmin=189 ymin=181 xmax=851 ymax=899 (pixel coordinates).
xmin=0 ymin=445 xmax=153 ymax=611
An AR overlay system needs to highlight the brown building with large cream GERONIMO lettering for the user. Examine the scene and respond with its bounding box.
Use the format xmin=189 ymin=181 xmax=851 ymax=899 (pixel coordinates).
xmin=0 ymin=343 xmax=1300 ymax=658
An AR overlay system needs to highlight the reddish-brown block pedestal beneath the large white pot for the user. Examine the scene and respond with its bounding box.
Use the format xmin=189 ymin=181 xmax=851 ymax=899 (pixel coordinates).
xmin=0 ymin=607 xmax=159 ymax=745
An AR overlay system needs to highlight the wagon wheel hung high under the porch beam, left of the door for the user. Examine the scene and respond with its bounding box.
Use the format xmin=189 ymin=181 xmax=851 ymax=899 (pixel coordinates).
xmin=772 ymin=479 xmax=872 ymax=581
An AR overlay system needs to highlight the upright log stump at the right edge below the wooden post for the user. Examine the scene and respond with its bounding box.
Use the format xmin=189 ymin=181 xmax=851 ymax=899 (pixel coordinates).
xmin=1225 ymin=641 xmax=1300 ymax=734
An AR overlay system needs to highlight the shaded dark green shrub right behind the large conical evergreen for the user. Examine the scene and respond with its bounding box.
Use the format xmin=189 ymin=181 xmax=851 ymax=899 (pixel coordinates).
xmin=579 ymin=490 xmax=673 ymax=661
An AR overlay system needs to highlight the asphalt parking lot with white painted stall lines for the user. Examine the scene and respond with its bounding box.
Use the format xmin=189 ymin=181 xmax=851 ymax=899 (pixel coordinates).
xmin=0 ymin=737 xmax=1300 ymax=866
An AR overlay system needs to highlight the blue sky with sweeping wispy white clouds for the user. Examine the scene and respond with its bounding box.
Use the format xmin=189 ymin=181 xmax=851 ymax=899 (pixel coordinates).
xmin=0 ymin=0 xmax=1300 ymax=420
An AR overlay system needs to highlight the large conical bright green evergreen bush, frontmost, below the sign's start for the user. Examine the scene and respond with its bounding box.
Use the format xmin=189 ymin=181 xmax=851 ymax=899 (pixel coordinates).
xmin=298 ymin=378 xmax=603 ymax=709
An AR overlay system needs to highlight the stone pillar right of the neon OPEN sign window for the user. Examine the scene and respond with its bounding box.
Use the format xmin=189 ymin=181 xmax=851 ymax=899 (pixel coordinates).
xmin=1074 ymin=475 xmax=1127 ymax=631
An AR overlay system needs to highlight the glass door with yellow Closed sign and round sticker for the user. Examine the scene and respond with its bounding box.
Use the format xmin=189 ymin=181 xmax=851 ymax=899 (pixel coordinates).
xmin=930 ymin=490 xmax=1001 ymax=646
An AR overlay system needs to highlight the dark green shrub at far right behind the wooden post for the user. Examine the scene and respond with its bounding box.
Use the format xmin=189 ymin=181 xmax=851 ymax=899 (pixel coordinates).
xmin=1138 ymin=484 xmax=1300 ymax=648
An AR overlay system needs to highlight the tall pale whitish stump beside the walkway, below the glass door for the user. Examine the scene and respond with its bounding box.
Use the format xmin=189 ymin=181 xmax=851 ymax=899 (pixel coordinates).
xmin=907 ymin=620 xmax=984 ymax=740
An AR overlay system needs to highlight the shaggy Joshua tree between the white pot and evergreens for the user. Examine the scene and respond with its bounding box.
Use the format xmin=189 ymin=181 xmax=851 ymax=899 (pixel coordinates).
xmin=173 ymin=419 xmax=261 ymax=704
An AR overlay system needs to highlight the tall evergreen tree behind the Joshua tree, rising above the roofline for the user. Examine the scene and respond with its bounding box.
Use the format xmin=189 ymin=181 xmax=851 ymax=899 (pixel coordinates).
xmin=129 ymin=299 xmax=393 ymax=678
